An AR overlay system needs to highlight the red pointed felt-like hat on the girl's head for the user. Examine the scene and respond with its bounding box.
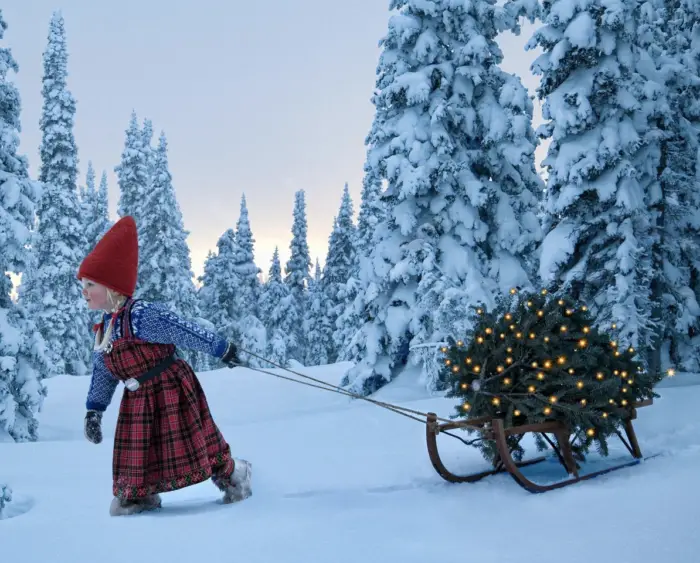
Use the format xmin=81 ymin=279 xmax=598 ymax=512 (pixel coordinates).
xmin=78 ymin=215 xmax=139 ymax=297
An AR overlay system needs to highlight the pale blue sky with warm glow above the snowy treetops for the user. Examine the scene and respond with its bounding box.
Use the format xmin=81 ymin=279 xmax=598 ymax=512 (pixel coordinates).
xmin=2 ymin=0 xmax=540 ymax=282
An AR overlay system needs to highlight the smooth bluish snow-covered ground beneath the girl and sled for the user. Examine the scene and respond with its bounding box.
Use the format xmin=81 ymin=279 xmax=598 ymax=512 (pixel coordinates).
xmin=0 ymin=364 xmax=700 ymax=563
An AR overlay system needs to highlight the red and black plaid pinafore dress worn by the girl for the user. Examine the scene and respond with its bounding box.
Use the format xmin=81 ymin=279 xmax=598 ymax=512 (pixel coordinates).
xmin=104 ymin=301 xmax=233 ymax=499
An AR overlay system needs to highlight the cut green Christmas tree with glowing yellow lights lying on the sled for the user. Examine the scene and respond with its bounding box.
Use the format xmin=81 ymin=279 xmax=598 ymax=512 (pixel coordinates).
xmin=442 ymin=289 xmax=660 ymax=461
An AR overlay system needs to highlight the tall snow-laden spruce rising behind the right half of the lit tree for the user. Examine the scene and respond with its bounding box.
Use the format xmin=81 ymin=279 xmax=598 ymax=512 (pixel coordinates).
xmin=528 ymin=0 xmax=665 ymax=362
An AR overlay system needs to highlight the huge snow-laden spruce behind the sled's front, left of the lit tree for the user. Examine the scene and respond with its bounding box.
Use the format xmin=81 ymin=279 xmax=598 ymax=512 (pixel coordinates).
xmin=347 ymin=0 xmax=541 ymax=394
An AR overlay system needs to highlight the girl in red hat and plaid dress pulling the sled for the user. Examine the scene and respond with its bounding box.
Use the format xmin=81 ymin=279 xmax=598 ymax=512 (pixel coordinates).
xmin=78 ymin=217 xmax=252 ymax=516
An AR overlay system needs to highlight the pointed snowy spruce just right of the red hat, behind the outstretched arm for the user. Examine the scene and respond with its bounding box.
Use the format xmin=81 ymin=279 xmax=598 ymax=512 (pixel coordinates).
xmin=136 ymin=133 xmax=200 ymax=369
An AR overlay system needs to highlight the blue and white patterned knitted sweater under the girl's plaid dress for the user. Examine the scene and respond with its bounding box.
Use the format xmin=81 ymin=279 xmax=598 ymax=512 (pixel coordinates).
xmin=86 ymin=300 xmax=228 ymax=411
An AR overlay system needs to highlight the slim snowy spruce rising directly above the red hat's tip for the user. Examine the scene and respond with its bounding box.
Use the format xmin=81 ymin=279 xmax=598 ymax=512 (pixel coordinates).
xmin=114 ymin=112 xmax=150 ymax=231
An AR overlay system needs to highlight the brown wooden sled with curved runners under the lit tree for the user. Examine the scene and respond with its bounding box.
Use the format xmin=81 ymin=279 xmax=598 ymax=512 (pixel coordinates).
xmin=426 ymin=399 xmax=656 ymax=493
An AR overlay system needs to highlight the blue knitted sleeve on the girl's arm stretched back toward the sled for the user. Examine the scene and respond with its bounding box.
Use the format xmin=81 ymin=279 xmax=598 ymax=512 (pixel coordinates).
xmin=131 ymin=301 xmax=228 ymax=358
